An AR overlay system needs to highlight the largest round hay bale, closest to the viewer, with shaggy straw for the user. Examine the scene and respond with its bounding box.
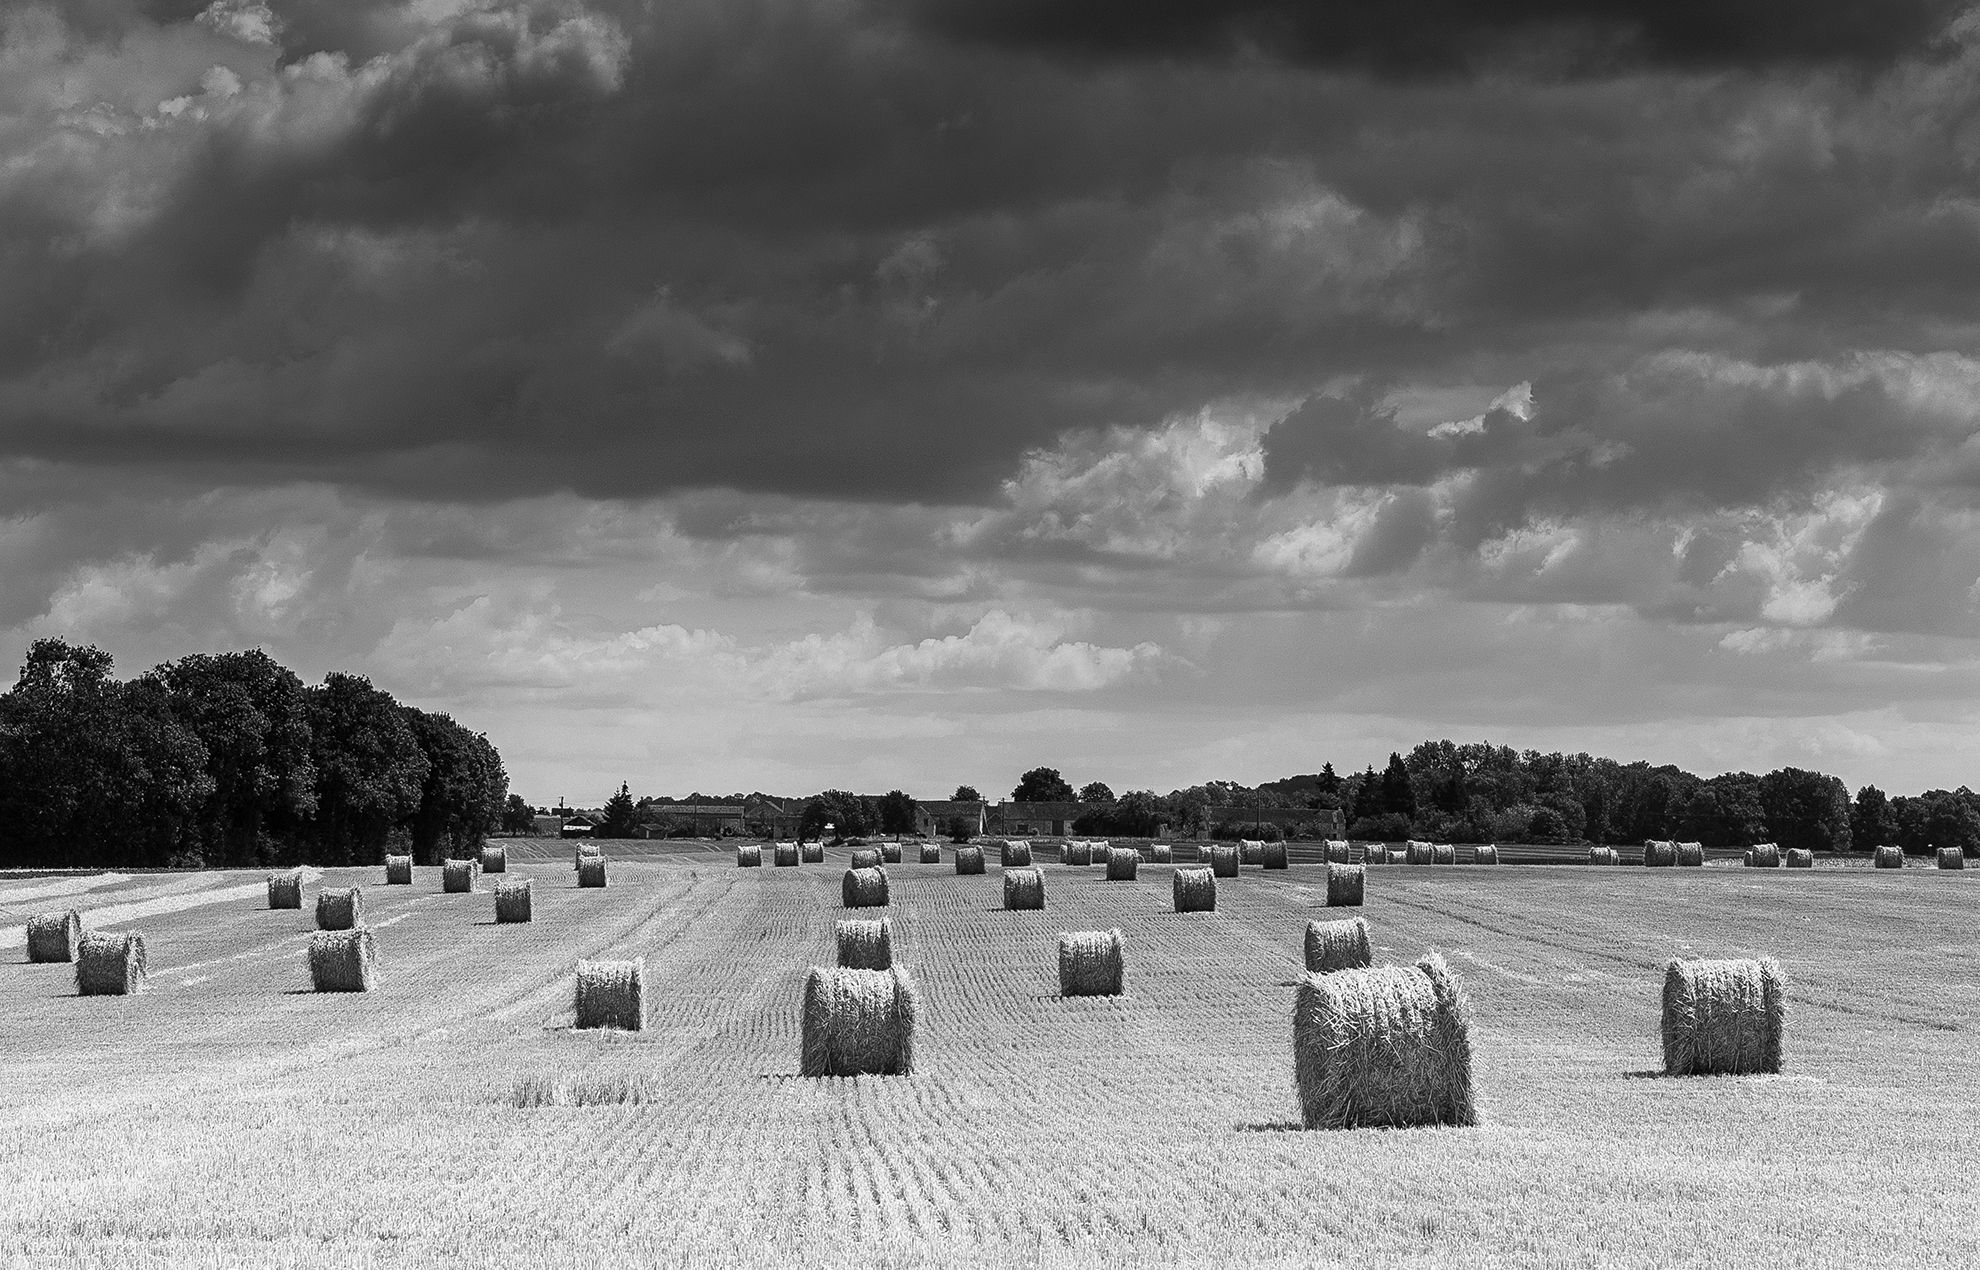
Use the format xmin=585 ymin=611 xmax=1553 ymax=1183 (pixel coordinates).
xmin=1293 ymin=953 xmax=1479 ymax=1129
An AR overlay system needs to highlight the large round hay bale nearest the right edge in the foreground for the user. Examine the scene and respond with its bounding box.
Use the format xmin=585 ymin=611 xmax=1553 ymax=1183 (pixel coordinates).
xmin=1663 ymin=957 xmax=1788 ymax=1076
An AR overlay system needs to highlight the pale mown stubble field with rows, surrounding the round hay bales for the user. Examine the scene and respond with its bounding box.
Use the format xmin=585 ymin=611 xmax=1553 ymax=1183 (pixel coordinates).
xmin=0 ymin=848 xmax=1980 ymax=1268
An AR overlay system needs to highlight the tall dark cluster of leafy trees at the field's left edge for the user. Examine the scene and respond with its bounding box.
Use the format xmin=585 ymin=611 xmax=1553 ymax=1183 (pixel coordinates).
xmin=0 ymin=640 xmax=506 ymax=868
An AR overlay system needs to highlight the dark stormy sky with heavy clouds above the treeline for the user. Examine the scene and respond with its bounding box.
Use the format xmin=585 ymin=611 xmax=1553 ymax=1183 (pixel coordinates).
xmin=0 ymin=0 xmax=1980 ymax=804
